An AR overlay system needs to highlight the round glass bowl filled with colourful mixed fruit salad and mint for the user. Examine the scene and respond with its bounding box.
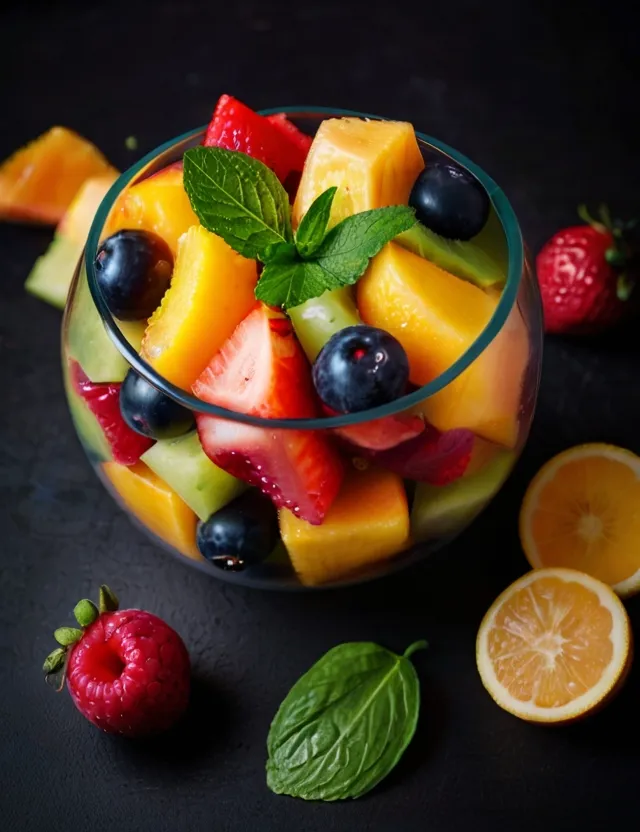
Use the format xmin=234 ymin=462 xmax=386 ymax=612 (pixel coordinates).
xmin=63 ymin=95 xmax=541 ymax=587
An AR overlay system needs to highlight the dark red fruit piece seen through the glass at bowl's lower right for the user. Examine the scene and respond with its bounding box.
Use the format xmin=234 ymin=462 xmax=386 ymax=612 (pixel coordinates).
xmin=373 ymin=425 xmax=474 ymax=485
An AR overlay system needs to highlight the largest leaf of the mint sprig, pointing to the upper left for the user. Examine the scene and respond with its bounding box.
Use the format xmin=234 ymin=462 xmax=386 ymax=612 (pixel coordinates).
xmin=184 ymin=147 xmax=293 ymax=259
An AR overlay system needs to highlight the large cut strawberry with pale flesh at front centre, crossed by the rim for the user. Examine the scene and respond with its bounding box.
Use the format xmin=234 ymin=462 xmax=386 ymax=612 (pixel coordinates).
xmin=193 ymin=305 xmax=343 ymax=525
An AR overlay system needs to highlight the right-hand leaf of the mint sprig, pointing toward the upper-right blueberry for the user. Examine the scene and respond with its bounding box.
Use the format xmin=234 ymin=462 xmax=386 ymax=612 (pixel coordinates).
xmin=314 ymin=205 xmax=416 ymax=288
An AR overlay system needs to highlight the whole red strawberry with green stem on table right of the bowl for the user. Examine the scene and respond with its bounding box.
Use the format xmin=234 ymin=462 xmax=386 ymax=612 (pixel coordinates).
xmin=536 ymin=206 xmax=637 ymax=335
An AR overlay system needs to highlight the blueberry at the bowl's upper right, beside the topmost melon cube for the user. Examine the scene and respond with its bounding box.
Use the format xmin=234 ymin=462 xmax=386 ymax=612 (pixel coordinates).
xmin=409 ymin=161 xmax=491 ymax=240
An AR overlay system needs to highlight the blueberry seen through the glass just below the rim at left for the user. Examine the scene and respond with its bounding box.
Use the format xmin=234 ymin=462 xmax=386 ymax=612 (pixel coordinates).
xmin=120 ymin=370 xmax=195 ymax=439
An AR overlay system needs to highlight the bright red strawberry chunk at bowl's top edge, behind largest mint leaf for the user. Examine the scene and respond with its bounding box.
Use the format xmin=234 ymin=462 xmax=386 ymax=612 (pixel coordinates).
xmin=203 ymin=95 xmax=299 ymax=182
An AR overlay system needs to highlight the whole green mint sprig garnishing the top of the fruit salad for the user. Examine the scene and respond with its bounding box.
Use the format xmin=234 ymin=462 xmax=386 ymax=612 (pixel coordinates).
xmin=184 ymin=147 xmax=416 ymax=309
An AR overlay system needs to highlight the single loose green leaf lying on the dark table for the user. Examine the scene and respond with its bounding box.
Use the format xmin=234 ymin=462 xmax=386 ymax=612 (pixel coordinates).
xmin=267 ymin=642 xmax=423 ymax=800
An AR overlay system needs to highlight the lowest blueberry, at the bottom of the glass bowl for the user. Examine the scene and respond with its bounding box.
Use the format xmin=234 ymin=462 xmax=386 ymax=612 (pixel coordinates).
xmin=196 ymin=489 xmax=279 ymax=572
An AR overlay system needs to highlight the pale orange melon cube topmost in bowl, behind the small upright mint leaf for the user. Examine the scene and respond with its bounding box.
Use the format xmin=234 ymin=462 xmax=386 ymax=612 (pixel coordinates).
xmin=293 ymin=118 xmax=424 ymax=227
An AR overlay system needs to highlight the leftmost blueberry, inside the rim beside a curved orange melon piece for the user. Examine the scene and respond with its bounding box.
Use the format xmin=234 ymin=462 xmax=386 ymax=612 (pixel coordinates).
xmin=95 ymin=231 xmax=173 ymax=321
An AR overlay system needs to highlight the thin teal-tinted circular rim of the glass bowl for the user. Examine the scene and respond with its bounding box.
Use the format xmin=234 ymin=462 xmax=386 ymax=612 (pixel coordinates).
xmin=84 ymin=106 xmax=524 ymax=430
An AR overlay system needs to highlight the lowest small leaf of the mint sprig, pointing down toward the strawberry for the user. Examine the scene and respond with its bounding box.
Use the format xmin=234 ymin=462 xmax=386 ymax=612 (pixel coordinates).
xmin=256 ymin=260 xmax=340 ymax=309
